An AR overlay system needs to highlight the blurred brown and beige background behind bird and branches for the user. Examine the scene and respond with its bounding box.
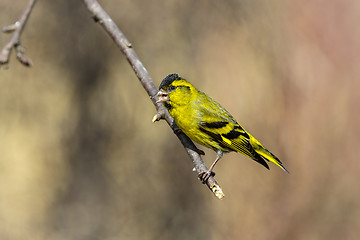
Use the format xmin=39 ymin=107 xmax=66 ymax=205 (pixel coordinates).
xmin=0 ymin=0 xmax=360 ymax=240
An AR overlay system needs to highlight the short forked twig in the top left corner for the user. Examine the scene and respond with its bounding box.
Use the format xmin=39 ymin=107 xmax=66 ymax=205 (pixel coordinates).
xmin=0 ymin=0 xmax=36 ymax=67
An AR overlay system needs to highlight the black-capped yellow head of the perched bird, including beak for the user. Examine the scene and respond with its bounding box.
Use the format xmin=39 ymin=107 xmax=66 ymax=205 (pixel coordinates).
xmin=157 ymin=73 xmax=195 ymax=109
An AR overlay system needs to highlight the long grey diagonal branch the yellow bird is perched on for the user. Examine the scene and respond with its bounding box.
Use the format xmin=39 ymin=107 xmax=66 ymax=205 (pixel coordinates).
xmin=84 ymin=0 xmax=224 ymax=199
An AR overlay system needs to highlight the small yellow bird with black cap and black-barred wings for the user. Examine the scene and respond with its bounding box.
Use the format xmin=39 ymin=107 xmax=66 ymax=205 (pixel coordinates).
xmin=157 ymin=73 xmax=289 ymax=182
